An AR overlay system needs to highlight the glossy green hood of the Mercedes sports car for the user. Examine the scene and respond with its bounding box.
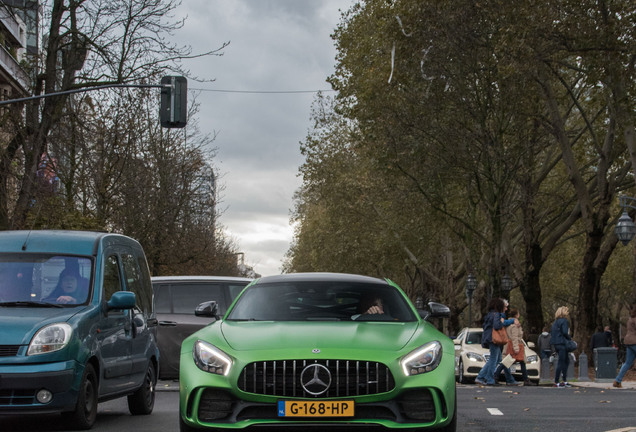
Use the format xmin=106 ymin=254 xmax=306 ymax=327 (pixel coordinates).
xmin=218 ymin=321 xmax=420 ymax=352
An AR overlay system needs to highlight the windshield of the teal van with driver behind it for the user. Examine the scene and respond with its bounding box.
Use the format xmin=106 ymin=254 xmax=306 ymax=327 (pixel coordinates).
xmin=0 ymin=254 xmax=92 ymax=307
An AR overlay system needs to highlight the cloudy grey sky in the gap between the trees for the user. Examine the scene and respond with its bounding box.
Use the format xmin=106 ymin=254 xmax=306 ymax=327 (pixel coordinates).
xmin=177 ymin=0 xmax=352 ymax=276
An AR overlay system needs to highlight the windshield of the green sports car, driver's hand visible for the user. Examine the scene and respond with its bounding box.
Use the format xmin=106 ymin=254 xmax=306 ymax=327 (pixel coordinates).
xmin=226 ymin=281 xmax=417 ymax=322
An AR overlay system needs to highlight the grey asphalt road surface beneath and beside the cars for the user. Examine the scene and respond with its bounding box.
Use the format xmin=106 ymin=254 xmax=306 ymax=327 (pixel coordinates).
xmin=0 ymin=382 xmax=636 ymax=432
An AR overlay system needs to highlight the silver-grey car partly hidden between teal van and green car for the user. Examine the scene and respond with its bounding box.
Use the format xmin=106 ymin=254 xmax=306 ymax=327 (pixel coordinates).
xmin=152 ymin=276 xmax=252 ymax=379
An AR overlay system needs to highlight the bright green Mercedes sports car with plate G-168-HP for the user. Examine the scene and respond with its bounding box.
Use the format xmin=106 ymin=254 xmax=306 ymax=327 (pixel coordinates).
xmin=179 ymin=273 xmax=457 ymax=432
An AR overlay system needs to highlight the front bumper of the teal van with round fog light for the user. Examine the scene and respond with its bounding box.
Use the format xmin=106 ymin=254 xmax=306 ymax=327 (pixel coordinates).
xmin=0 ymin=361 xmax=83 ymax=414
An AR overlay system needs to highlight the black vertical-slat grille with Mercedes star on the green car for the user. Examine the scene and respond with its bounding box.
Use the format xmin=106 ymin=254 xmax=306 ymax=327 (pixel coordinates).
xmin=238 ymin=360 xmax=395 ymax=398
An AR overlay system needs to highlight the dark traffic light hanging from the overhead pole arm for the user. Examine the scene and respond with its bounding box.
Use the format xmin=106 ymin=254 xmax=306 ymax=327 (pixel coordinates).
xmin=159 ymin=76 xmax=188 ymax=128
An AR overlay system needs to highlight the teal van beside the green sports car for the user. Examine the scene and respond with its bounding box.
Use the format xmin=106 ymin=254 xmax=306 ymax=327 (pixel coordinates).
xmin=0 ymin=231 xmax=159 ymax=429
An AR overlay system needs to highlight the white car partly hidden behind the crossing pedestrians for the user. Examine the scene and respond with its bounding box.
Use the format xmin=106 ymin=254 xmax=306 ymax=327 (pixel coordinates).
xmin=453 ymin=327 xmax=541 ymax=384
